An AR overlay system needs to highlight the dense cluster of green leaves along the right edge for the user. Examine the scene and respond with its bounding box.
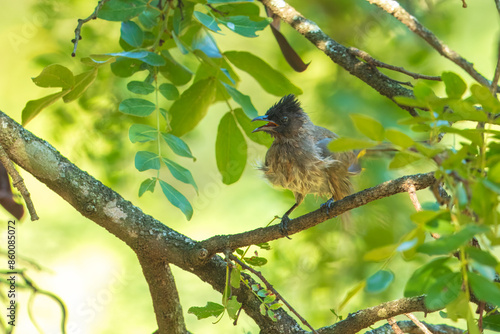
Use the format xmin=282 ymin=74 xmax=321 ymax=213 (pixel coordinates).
xmin=330 ymin=72 xmax=500 ymax=333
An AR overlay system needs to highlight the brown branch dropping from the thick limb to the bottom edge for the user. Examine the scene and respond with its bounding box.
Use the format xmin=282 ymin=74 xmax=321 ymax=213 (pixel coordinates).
xmin=139 ymin=256 xmax=188 ymax=334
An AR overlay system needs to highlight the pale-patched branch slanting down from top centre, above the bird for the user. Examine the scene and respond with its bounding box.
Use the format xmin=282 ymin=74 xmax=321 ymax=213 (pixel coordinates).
xmin=262 ymin=0 xmax=415 ymax=114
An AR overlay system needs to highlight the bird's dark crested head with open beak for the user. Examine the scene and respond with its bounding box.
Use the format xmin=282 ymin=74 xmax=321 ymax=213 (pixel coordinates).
xmin=252 ymin=94 xmax=309 ymax=137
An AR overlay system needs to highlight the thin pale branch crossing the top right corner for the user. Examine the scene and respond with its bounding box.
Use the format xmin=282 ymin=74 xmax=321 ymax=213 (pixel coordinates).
xmin=367 ymin=0 xmax=490 ymax=87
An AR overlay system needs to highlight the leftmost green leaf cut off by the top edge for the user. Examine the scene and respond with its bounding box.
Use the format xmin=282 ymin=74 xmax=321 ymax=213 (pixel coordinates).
xmin=97 ymin=0 xmax=148 ymax=21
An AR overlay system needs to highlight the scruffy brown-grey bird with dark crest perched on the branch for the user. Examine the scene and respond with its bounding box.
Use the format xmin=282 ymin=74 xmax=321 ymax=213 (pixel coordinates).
xmin=252 ymin=94 xmax=361 ymax=237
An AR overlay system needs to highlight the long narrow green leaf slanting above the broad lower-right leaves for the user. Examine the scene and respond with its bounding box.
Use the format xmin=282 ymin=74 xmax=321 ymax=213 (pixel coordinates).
xmin=418 ymin=225 xmax=490 ymax=255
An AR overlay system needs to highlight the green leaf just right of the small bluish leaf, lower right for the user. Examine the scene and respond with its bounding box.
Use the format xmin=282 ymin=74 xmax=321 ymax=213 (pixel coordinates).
xmin=404 ymin=257 xmax=452 ymax=297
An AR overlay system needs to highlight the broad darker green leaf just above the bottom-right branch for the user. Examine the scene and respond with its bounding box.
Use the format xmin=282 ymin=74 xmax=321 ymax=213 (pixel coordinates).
xmin=425 ymin=272 xmax=462 ymax=310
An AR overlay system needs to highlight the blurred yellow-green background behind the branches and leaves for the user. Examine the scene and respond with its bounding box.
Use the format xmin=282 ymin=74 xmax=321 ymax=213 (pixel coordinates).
xmin=0 ymin=0 xmax=498 ymax=334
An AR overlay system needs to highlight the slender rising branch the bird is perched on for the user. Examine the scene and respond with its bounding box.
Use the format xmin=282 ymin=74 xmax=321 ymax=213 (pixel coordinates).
xmin=200 ymin=172 xmax=436 ymax=254
